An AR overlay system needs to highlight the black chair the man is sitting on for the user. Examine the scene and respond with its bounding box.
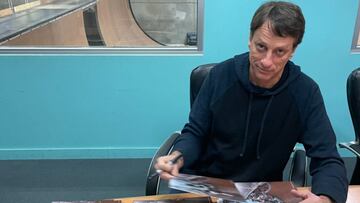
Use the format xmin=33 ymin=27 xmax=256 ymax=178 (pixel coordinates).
xmin=145 ymin=63 xmax=307 ymax=195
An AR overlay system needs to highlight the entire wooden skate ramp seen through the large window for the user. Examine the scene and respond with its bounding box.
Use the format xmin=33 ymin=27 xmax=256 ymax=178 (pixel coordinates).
xmin=0 ymin=0 xmax=163 ymax=48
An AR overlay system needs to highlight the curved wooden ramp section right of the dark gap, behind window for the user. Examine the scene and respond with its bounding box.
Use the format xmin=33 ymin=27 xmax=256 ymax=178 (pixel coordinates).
xmin=97 ymin=0 xmax=162 ymax=47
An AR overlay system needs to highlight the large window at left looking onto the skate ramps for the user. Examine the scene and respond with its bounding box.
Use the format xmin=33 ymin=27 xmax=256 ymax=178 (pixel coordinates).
xmin=0 ymin=0 xmax=203 ymax=54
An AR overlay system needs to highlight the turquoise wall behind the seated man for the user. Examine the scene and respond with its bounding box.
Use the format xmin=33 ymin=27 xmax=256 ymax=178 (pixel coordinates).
xmin=0 ymin=0 xmax=360 ymax=159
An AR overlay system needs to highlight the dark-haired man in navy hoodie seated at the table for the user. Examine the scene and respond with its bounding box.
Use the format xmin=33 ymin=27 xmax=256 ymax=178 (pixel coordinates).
xmin=155 ymin=2 xmax=348 ymax=203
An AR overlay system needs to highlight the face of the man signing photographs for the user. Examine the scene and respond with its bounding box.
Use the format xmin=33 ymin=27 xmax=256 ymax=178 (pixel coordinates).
xmin=249 ymin=22 xmax=295 ymax=88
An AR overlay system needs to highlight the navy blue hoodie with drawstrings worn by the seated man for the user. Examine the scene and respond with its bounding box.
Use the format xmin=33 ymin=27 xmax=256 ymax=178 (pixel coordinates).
xmin=174 ymin=53 xmax=348 ymax=202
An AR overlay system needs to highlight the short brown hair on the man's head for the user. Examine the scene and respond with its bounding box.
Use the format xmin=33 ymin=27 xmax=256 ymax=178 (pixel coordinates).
xmin=250 ymin=1 xmax=305 ymax=47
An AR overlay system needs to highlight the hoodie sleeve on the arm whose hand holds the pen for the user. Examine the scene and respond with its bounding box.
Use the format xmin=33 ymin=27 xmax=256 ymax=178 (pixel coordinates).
xmin=173 ymin=68 xmax=214 ymax=168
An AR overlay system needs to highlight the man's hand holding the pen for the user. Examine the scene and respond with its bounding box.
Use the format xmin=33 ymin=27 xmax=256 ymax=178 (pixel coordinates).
xmin=154 ymin=151 xmax=184 ymax=180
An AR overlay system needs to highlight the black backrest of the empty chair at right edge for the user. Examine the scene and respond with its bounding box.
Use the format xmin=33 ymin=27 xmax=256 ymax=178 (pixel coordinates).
xmin=346 ymin=68 xmax=360 ymax=141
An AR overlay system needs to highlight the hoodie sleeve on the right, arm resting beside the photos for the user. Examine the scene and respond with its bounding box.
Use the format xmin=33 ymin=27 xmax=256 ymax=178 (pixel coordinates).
xmin=300 ymin=85 xmax=348 ymax=203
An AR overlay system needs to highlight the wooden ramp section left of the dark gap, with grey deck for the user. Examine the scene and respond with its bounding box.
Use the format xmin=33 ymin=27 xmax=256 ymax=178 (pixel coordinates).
xmin=0 ymin=0 xmax=96 ymax=46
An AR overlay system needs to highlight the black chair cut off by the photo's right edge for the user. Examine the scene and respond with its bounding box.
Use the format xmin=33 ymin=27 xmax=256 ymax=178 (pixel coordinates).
xmin=339 ymin=68 xmax=360 ymax=185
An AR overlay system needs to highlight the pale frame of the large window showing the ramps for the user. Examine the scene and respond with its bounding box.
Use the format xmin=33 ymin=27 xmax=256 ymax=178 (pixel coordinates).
xmin=0 ymin=0 xmax=204 ymax=56
